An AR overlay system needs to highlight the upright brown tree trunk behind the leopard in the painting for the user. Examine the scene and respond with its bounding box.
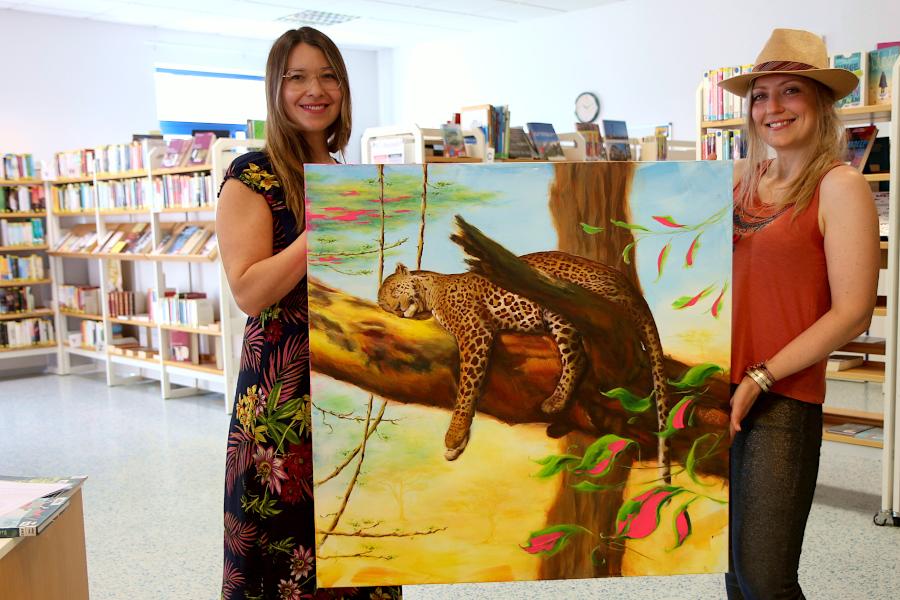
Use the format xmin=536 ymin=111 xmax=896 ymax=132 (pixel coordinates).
xmin=541 ymin=162 xmax=640 ymax=579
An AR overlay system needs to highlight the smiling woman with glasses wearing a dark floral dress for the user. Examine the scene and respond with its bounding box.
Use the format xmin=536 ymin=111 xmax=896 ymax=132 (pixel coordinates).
xmin=216 ymin=27 xmax=400 ymax=600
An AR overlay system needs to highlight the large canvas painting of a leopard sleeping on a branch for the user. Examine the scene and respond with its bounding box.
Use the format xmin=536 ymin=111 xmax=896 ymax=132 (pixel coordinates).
xmin=306 ymin=161 xmax=732 ymax=587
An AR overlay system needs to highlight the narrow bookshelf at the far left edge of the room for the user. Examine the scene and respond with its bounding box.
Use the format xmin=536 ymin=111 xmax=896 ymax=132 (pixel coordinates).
xmin=0 ymin=169 xmax=59 ymax=360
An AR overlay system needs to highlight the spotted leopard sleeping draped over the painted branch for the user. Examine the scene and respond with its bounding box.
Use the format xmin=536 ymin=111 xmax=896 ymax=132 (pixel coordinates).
xmin=378 ymin=252 xmax=669 ymax=480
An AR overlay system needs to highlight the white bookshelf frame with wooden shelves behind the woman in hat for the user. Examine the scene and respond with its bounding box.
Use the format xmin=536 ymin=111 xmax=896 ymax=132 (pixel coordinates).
xmin=696 ymin=61 xmax=900 ymax=522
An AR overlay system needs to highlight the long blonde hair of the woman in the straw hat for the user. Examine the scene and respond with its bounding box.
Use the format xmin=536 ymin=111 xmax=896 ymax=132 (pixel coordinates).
xmin=738 ymin=78 xmax=847 ymax=217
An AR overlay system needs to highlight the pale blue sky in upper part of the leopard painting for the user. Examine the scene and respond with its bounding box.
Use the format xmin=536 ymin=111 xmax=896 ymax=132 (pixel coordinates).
xmin=307 ymin=161 xmax=731 ymax=368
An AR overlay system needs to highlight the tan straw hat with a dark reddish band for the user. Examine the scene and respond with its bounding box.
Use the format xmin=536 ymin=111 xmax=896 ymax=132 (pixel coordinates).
xmin=719 ymin=29 xmax=859 ymax=100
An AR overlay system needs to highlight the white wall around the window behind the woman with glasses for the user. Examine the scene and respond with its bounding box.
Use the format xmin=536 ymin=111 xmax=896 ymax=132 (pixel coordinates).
xmin=0 ymin=10 xmax=378 ymax=162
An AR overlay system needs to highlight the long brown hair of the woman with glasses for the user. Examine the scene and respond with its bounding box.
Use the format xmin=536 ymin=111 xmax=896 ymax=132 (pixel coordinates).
xmin=264 ymin=27 xmax=352 ymax=231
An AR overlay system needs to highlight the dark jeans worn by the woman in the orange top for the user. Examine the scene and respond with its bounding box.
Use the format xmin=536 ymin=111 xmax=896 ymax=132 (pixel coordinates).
xmin=725 ymin=393 xmax=822 ymax=600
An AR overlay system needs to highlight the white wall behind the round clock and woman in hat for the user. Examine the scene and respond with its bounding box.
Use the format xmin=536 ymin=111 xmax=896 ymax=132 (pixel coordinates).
xmin=382 ymin=0 xmax=900 ymax=140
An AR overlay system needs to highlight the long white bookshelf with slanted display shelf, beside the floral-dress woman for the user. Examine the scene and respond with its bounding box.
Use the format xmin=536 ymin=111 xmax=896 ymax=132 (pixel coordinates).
xmin=44 ymin=140 xmax=262 ymax=411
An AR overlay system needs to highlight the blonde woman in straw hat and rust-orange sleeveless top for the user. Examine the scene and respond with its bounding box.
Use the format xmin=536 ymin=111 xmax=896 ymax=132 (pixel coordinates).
xmin=722 ymin=29 xmax=879 ymax=600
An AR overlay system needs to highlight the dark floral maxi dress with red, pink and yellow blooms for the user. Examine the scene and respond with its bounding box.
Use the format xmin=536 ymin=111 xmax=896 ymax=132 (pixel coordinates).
xmin=222 ymin=152 xmax=400 ymax=600
